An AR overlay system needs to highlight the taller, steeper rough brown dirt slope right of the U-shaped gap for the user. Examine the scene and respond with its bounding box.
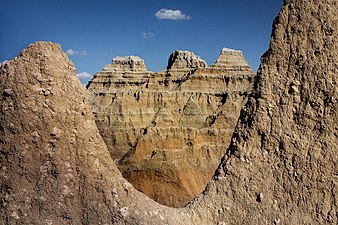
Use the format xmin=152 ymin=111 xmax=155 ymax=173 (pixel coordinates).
xmin=189 ymin=0 xmax=338 ymax=224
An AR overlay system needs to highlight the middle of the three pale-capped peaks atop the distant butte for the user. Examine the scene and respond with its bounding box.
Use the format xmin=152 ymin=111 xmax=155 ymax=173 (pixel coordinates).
xmin=167 ymin=50 xmax=208 ymax=70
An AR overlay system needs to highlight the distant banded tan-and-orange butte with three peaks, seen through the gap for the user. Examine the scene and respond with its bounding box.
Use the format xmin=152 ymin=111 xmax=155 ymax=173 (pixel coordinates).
xmin=88 ymin=49 xmax=254 ymax=207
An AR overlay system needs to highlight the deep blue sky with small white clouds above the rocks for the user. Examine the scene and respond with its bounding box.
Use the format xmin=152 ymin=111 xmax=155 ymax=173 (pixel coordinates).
xmin=0 ymin=0 xmax=283 ymax=83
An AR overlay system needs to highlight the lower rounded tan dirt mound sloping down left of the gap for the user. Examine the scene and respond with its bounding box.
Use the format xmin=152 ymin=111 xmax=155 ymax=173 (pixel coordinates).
xmin=0 ymin=42 xmax=182 ymax=224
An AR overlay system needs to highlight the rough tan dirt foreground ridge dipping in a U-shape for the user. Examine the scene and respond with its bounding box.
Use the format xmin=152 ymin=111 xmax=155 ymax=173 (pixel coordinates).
xmin=0 ymin=0 xmax=338 ymax=224
